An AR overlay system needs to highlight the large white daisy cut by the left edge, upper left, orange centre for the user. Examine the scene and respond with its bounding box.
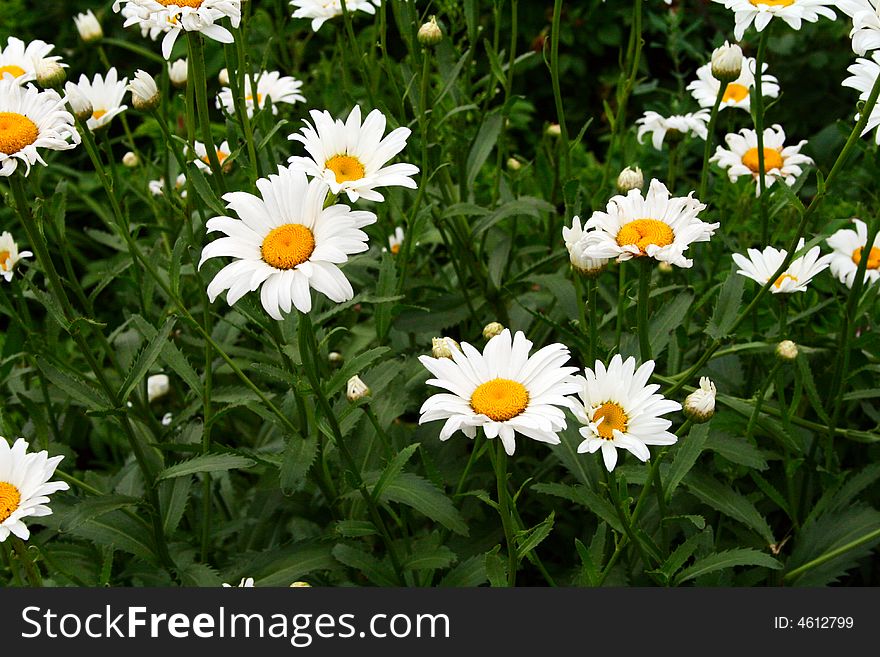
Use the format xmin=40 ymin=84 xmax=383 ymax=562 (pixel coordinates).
xmin=0 ymin=76 xmax=80 ymax=176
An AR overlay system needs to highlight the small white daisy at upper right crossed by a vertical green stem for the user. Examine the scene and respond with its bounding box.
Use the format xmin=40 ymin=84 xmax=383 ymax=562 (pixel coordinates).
xmin=709 ymin=125 xmax=813 ymax=195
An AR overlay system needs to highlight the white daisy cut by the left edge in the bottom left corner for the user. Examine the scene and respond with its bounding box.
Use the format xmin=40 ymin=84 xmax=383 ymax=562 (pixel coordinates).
xmin=0 ymin=436 xmax=70 ymax=543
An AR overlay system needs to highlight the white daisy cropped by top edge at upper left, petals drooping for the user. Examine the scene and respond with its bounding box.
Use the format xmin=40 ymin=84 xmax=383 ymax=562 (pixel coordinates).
xmin=113 ymin=0 xmax=241 ymax=59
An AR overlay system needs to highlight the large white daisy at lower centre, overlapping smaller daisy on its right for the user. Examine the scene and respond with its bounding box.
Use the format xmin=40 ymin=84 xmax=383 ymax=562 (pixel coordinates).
xmin=419 ymin=329 xmax=578 ymax=455
